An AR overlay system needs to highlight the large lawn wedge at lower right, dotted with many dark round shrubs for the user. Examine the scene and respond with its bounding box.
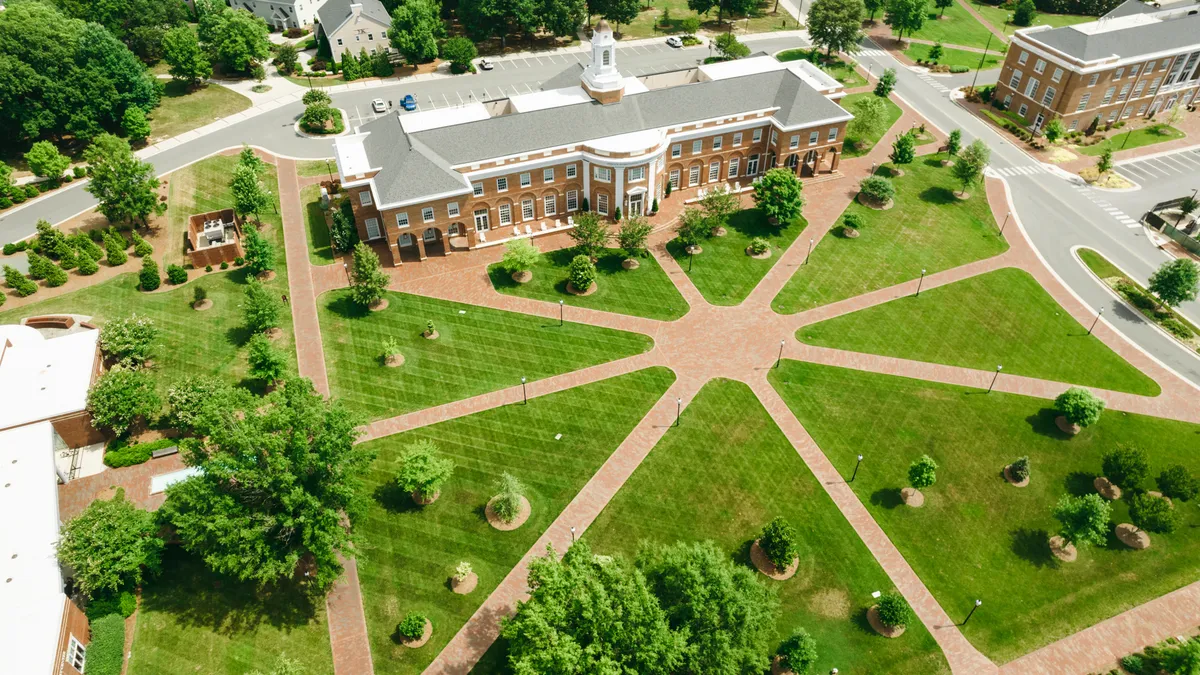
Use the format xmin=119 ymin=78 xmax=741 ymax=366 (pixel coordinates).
xmin=770 ymin=360 xmax=1200 ymax=664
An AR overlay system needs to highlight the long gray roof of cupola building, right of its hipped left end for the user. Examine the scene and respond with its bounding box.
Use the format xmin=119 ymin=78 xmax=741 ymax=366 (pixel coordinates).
xmin=412 ymin=70 xmax=851 ymax=166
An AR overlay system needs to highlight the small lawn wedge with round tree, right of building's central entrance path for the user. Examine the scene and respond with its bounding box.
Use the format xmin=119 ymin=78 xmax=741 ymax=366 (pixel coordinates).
xmin=667 ymin=209 xmax=809 ymax=305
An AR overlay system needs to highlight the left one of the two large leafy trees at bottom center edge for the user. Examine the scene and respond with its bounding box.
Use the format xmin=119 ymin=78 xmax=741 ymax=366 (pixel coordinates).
xmin=500 ymin=540 xmax=684 ymax=675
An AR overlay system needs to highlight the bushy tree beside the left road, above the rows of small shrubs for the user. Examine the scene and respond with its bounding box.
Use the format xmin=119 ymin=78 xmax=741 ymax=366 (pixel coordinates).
xmin=83 ymin=133 xmax=167 ymax=225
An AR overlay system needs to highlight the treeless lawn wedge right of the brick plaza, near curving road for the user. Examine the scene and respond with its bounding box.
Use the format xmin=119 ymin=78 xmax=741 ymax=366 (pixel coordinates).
xmin=797 ymin=268 xmax=1160 ymax=396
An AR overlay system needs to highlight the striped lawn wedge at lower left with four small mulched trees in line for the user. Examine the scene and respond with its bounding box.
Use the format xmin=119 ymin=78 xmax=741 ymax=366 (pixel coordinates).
xmin=354 ymin=367 xmax=674 ymax=675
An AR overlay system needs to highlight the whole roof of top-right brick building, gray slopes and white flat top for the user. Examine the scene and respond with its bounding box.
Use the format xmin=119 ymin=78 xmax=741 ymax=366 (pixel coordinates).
xmin=1019 ymin=2 xmax=1200 ymax=61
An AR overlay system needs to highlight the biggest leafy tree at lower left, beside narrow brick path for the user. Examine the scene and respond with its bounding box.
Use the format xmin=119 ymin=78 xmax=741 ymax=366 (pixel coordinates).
xmin=160 ymin=378 xmax=373 ymax=591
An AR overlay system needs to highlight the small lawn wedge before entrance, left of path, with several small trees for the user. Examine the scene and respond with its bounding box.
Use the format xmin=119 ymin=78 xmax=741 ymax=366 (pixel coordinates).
xmin=487 ymin=249 xmax=688 ymax=321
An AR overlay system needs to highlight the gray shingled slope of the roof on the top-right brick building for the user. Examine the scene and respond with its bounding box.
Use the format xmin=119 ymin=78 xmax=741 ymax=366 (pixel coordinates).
xmin=1026 ymin=13 xmax=1200 ymax=61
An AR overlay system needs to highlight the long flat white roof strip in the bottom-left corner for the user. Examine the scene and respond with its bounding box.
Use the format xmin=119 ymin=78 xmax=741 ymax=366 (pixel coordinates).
xmin=0 ymin=420 xmax=68 ymax=674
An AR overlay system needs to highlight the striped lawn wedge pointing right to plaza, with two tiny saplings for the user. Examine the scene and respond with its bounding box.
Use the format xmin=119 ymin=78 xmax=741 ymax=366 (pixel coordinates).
xmin=317 ymin=291 xmax=654 ymax=419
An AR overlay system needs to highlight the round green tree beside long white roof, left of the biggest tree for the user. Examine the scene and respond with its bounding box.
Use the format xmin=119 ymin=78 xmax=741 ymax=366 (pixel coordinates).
xmin=58 ymin=490 xmax=164 ymax=597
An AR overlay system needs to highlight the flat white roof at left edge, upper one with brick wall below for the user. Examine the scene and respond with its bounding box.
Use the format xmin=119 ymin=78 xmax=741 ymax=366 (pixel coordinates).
xmin=0 ymin=324 xmax=100 ymax=429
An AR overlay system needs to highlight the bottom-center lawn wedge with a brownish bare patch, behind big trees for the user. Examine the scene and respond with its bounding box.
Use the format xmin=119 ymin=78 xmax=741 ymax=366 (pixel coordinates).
xmin=584 ymin=380 xmax=948 ymax=673
